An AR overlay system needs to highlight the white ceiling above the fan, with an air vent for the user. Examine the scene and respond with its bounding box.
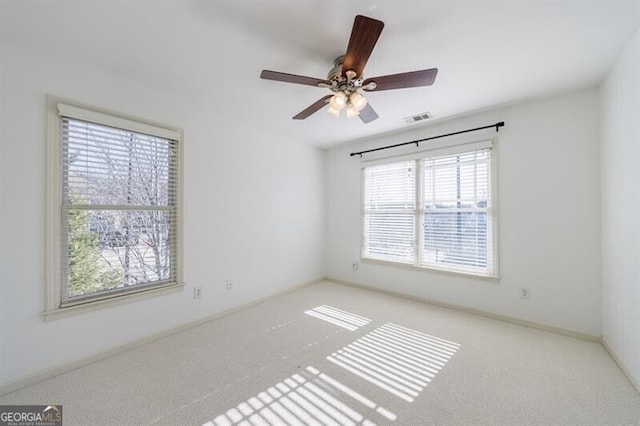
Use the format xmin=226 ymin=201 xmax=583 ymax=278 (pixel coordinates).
xmin=0 ymin=0 xmax=640 ymax=147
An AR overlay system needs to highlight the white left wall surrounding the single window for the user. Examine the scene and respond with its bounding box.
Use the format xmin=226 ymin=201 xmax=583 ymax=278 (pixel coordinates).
xmin=0 ymin=42 xmax=324 ymax=384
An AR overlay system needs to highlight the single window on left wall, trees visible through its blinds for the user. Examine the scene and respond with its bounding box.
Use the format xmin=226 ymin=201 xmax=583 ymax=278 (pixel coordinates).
xmin=48 ymin=103 xmax=181 ymax=311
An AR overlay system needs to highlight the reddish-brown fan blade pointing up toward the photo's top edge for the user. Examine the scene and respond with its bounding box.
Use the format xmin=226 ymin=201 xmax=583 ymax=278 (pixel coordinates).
xmin=342 ymin=15 xmax=384 ymax=77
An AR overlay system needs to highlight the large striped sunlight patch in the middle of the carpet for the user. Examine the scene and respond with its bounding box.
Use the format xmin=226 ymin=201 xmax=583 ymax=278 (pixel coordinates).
xmin=327 ymin=323 xmax=460 ymax=402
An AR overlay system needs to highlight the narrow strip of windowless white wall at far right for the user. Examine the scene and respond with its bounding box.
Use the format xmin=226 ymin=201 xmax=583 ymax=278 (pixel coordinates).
xmin=601 ymin=30 xmax=640 ymax=386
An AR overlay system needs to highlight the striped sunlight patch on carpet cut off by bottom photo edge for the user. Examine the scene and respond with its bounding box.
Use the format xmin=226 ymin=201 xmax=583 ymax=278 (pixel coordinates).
xmin=203 ymin=367 xmax=396 ymax=426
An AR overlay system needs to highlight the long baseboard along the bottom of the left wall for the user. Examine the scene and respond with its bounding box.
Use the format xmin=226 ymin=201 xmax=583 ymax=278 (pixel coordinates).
xmin=0 ymin=278 xmax=325 ymax=396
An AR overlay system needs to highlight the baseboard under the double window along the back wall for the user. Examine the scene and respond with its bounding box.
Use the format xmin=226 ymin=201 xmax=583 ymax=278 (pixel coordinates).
xmin=327 ymin=277 xmax=602 ymax=343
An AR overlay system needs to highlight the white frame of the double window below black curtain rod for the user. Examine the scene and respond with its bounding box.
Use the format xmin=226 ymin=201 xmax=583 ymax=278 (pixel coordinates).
xmin=360 ymin=138 xmax=500 ymax=279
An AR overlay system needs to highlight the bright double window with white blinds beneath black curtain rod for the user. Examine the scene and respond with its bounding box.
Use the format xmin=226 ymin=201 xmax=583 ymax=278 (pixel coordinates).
xmin=362 ymin=142 xmax=497 ymax=276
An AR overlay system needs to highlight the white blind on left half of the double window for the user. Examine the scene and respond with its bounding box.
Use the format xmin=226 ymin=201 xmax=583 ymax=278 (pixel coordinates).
xmin=364 ymin=161 xmax=416 ymax=263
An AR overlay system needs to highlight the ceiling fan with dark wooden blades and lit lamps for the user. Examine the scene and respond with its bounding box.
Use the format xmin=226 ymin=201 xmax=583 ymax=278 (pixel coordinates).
xmin=260 ymin=15 xmax=438 ymax=123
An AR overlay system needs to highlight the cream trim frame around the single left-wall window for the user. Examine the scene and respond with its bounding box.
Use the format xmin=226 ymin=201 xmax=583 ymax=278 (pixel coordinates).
xmin=43 ymin=95 xmax=184 ymax=320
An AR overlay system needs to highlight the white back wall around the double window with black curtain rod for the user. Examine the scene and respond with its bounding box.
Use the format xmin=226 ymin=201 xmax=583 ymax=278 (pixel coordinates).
xmin=326 ymin=89 xmax=602 ymax=336
